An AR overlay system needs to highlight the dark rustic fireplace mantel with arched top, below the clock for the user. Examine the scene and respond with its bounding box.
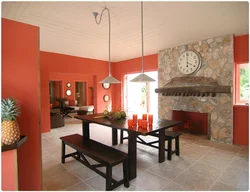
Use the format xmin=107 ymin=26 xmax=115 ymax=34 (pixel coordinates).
xmin=155 ymin=77 xmax=232 ymax=97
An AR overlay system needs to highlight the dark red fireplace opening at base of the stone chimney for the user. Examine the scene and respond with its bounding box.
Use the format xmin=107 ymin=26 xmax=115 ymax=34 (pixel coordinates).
xmin=173 ymin=110 xmax=210 ymax=139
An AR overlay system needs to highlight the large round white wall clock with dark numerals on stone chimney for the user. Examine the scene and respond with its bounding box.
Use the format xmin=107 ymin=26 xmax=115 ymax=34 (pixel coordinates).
xmin=177 ymin=51 xmax=201 ymax=75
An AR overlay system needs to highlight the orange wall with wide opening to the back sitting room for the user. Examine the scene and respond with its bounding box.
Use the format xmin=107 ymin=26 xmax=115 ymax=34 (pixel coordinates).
xmin=40 ymin=51 xmax=119 ymax=132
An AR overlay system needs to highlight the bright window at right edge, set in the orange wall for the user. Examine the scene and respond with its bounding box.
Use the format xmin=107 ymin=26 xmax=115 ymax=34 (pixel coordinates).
xmin=235 ymin=64 xmax=250 ymax=103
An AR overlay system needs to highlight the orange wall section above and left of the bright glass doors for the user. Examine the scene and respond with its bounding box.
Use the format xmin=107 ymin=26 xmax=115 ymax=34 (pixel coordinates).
xmin=112 ymin=54 xmax=158 ymax=108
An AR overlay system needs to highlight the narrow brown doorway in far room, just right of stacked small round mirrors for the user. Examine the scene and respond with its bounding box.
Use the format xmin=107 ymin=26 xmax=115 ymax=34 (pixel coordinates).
xmin=75 ymin=82 xmax=86 ymax=106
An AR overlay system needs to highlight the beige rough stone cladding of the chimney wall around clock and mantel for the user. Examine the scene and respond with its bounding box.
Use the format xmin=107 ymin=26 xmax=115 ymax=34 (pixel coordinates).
xmin=158 ymin=35 xmax=234 ymax=144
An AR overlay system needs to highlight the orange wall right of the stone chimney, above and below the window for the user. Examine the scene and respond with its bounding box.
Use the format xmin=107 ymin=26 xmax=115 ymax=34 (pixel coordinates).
xmin=233 ymin=34 xmax=249 ymax=145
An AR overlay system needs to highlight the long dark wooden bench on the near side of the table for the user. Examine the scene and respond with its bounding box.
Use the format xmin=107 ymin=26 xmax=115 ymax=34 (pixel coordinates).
xmin=60 ymin=134 xmax=129 ymax=190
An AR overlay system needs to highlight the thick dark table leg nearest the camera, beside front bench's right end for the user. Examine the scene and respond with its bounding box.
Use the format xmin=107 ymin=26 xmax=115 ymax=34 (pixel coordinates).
xmin=128 ymin=133 xmax=137 ymax=180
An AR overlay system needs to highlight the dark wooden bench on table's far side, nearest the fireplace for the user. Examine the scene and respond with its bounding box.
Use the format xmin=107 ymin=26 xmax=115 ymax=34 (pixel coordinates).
xmin=120 ymin=130 xmax=181 ymax=160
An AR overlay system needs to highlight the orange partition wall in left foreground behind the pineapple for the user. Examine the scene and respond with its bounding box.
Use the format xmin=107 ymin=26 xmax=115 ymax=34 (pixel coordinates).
xmin=2 ymin=19 xmax=42 ymax=190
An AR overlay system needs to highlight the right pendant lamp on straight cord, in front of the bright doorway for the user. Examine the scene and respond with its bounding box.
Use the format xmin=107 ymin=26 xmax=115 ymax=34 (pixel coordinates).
xmin=131 ymin=2 xmax=155 ymax=83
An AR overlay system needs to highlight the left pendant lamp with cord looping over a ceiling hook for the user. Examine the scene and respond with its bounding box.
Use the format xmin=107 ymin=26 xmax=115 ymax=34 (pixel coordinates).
xmin=93 ymin=7 xmax=121 ymax=84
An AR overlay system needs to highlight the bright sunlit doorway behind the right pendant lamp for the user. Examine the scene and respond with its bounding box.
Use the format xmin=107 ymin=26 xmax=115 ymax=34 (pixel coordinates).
xmin=124 ymin=71 xmax=158 ymax=114
